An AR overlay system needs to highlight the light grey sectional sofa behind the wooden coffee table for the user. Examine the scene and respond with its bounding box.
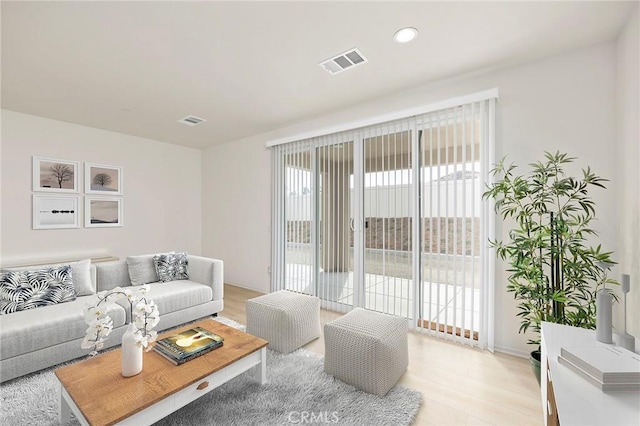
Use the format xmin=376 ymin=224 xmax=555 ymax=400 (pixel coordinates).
xmin=0 ymin=255 xmax=224 ymax=382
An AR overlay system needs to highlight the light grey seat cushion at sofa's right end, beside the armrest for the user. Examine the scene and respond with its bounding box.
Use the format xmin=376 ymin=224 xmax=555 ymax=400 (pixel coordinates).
xmin=118 ymin=280 xmax=213 ymax=318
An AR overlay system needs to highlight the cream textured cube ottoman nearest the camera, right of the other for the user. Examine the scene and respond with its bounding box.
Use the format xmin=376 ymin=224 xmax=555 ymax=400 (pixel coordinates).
xmin=324 ymin=308 xmax=409 ymax=396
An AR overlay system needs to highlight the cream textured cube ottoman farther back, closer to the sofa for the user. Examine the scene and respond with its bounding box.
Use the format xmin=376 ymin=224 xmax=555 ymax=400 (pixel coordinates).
xmin=247 ymin=290 xmax=320 ymax=354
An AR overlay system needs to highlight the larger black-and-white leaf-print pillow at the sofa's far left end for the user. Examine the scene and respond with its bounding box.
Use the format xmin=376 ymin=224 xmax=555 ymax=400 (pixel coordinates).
xmin=0 ymin=265 xmax=76 ymax=315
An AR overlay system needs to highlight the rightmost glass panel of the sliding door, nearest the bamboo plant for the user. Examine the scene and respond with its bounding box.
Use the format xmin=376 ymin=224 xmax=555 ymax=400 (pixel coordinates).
xmin=418 ymin=107 xmax=486 ymax=340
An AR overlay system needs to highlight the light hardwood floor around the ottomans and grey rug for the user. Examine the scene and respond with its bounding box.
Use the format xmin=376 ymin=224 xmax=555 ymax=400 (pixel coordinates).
xmin=220 ymin=284 xmax=543 ymax=425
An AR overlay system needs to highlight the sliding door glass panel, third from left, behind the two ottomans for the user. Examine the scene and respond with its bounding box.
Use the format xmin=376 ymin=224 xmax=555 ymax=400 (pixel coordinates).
xmin=362 ymin=122 xmax=415 ymax=318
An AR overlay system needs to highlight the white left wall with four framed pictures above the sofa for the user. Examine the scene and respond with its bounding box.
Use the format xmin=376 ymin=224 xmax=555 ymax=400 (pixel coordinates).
xmin=0 ymin=110 xmax=202 ymax=264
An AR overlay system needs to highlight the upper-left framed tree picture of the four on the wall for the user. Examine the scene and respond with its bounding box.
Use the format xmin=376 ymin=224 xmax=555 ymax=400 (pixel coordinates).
xmin=33 ymin=157 xmax=80 ymax=192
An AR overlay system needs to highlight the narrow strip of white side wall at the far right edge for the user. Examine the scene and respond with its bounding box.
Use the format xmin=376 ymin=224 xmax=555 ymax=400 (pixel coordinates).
xmin=616 ymin=5 xmax=640 ymax=350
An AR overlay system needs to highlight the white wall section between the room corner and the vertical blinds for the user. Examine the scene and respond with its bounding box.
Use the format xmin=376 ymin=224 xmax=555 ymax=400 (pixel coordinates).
xmin=202 ymin=140 xmax=271 ymax=293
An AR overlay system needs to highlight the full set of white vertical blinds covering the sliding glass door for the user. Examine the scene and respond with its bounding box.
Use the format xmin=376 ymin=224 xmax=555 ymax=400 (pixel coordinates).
xmin=272 ymin=93 xmax=495 ymax=350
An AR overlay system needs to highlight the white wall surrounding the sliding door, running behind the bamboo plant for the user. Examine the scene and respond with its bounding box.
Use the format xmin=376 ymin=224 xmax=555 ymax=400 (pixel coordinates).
xmin=202 ymin=43 xmax=619 ymax=354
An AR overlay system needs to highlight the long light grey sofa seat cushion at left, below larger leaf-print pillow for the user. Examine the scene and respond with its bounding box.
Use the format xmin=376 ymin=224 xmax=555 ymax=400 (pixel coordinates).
xmin=0 ymin=296 xmax=125 ymax=359
